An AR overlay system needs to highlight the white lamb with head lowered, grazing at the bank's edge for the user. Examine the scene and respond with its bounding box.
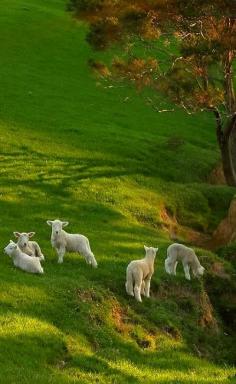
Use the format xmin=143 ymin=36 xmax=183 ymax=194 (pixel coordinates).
xmin=165 ymin=243 xmax=205 ymax=280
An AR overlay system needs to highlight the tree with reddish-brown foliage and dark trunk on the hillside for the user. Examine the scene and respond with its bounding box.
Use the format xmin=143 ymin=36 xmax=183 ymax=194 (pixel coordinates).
xmin=70 ymin=0 xmax=236 ymax=186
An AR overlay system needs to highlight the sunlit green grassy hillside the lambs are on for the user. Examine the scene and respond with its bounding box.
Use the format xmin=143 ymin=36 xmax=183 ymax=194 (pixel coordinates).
xmin=0 ymin=0 xmax=234 ymax=384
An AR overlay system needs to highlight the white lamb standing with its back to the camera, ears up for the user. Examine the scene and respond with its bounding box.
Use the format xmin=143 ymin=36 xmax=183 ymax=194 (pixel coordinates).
xmin=125 ymin=245 xmax=158 ymax=302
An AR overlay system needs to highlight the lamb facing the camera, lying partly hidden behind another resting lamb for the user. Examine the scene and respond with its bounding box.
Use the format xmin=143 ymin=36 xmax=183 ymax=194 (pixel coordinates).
xmin=13 ymin=232 xmax=45 ymax=261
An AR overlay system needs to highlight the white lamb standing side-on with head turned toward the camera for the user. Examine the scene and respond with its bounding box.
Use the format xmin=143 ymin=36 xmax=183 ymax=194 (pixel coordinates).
xmin=47 ymin=220 xmax=97 ymax=268
